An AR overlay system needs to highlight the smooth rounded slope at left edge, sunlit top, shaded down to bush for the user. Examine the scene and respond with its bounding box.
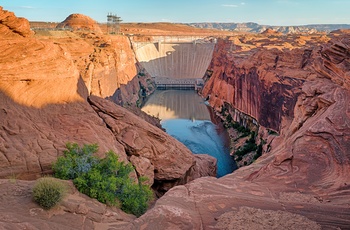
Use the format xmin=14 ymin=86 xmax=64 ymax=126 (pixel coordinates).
xmin=0 ymin=39 xmax=126 ymax=178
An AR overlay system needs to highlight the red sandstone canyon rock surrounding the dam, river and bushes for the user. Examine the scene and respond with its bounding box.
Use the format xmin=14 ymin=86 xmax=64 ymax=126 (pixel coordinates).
xmin=0 ymin=7 xmax=350 ymax=229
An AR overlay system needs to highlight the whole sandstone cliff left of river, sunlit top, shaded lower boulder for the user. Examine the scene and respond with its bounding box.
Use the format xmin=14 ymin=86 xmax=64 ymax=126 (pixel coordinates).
xmin=0 ymin=8 xmax=214 ymax=191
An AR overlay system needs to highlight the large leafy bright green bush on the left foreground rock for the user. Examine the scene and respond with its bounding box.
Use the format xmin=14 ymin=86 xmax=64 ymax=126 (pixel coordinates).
xmin=53 ymin=144 xmax=153 ymax=216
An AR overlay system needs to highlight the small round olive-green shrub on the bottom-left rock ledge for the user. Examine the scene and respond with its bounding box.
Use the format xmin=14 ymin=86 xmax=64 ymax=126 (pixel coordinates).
xmin=32 ymin=177 xmax=66 ymax=209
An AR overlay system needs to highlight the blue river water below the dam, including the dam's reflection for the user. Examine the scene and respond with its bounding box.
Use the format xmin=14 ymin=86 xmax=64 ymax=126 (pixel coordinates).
xmin=142 ymin=90 xmax=236 ymax=177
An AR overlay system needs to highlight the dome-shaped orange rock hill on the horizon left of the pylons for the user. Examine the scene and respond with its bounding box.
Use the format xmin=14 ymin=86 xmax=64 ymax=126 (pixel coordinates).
xmin=56 ymin=14 xmax=102 ymax=33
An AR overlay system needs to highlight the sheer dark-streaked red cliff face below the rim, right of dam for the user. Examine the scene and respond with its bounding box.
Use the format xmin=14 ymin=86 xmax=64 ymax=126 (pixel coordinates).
xmin=202 ymin=37 xmax=306 ymax=131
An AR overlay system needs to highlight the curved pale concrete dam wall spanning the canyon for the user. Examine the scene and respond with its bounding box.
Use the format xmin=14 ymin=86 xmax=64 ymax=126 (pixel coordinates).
xmin=131 ymin=36 xmax=216 ymax=88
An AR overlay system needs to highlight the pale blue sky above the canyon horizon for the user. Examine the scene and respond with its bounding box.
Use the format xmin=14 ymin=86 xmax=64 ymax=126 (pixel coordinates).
xmin=0 ymin=0 xmax=350 ymax=25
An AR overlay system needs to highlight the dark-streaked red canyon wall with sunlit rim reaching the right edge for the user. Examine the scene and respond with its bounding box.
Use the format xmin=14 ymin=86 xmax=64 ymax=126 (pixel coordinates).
xmin=203 ymin=33 xmax=349 ymax=131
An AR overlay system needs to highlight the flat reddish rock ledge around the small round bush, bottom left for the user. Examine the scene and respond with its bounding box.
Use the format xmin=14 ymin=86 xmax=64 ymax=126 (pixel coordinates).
xmin=0 ymin=179 xmax=135 ymax=230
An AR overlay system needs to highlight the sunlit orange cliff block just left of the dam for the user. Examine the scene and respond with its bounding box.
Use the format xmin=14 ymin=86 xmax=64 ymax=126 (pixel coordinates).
xmin=53 ymin=34 xmax=137 ymax=98
